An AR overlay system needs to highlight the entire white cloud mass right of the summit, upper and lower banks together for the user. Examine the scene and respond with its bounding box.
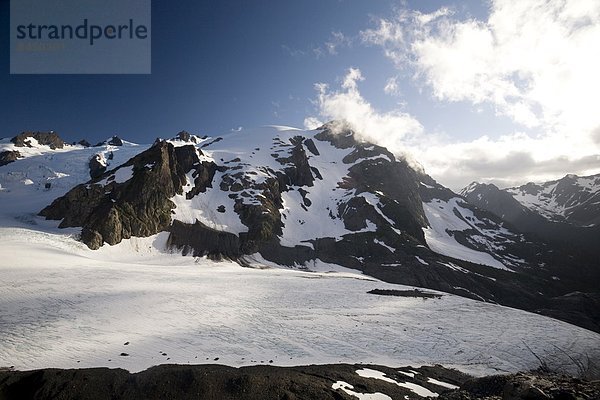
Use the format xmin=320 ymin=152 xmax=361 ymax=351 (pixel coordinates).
xmin=317 ymin=0 xmax=600 ymax=189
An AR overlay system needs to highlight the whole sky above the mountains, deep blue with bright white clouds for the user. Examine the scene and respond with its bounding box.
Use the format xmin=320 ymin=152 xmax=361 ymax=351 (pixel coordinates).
xmin=0 ymin=0 xmax=600 ymax=188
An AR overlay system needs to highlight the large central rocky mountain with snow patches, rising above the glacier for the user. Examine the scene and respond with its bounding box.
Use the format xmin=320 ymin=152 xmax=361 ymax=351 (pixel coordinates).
xmin=0 ymin=124 xmax=600 ymax=330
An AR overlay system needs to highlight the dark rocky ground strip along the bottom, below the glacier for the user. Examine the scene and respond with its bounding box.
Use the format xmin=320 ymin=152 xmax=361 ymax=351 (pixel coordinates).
xmin=0 ymin=364 xmax=600 ymax=400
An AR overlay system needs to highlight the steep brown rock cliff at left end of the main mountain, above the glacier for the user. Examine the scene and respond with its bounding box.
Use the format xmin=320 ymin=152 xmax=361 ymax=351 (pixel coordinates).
xmin=40 ymin=142 xmax=214 ymax=248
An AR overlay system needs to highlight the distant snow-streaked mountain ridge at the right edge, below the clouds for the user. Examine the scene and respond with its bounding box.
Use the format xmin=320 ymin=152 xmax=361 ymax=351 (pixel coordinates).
xmin=461 ymin=175 xmax=600 ymax=257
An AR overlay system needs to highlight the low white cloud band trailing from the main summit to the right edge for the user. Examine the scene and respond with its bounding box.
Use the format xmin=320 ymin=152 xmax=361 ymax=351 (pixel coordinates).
xmin=304 ymin=68 xmax=600 ymax=191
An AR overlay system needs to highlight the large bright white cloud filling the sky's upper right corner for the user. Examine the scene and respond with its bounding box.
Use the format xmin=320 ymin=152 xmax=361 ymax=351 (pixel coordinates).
xmin=361 ymin=0 xmax=600 ymax=138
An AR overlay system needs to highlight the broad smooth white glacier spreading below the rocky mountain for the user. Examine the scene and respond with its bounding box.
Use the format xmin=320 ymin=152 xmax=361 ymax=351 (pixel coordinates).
xmin=0 ymin=223 xmax=600 ymax=375
